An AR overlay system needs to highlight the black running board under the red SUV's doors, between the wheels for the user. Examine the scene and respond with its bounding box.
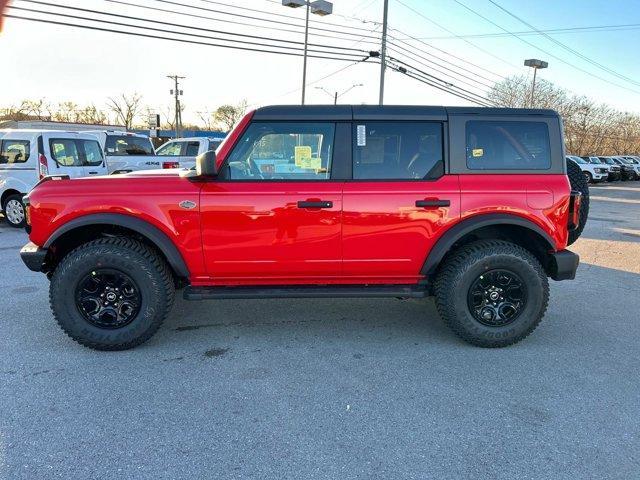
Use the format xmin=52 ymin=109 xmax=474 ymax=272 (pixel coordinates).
xmin=183 ymin=285 xmax=427 ymax=300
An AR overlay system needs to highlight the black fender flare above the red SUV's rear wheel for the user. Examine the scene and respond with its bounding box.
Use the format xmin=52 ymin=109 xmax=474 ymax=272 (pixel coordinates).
xmin=420 ymin=213 xmax=556 ymax=275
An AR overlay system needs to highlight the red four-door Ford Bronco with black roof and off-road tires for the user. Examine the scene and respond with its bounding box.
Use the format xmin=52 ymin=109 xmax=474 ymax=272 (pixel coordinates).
xmin=21 ymin=106 xmax=588 ymax=350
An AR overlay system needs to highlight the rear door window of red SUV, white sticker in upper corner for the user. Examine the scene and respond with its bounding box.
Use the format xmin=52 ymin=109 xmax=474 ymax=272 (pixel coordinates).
xmin=353 ymin=122 xmax=444 ymax=180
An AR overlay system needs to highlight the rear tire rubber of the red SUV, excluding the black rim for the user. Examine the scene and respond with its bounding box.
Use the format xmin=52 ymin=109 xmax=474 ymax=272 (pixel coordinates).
xmin=434 ymin=240 xmax=549 ymax=348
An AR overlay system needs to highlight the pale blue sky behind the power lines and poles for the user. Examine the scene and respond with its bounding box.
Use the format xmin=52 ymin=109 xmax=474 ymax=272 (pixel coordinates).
xmin=0 ymin=0 xmax=640 ymax=123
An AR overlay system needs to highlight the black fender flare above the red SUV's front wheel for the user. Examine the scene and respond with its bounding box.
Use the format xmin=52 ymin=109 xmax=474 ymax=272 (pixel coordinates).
xmin=44 ymin=213 xmax=189 ymax=278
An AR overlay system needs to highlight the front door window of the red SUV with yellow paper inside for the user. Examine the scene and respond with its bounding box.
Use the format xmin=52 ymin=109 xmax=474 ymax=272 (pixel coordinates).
xmin=225 ymin=122 xmax=335 ymax=180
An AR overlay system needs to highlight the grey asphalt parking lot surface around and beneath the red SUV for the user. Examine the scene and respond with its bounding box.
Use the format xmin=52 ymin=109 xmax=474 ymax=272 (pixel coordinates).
xmin=0 ymin=182 xmax=640 ymax=479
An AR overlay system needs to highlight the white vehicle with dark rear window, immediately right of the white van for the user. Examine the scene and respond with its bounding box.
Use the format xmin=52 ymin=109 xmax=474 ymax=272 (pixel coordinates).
xmin=84 ymin=130 xmax=162 ymax=173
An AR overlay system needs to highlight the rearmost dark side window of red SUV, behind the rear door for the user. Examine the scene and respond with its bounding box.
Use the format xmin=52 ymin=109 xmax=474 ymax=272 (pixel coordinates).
xmin=466 ymin=121 xmax=551 ymax=170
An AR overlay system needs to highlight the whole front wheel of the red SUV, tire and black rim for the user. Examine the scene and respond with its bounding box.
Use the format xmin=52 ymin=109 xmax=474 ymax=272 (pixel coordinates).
xmin=49 ymin=237 xmax=175 ymax=350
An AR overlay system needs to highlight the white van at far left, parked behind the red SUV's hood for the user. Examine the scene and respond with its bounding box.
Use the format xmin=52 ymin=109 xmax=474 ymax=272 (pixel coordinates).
xmin=0 ymin=130 xmax=107 ymax=227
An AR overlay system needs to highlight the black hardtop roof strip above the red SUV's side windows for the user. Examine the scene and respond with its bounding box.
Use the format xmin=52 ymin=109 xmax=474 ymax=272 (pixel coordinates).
xmin=254 ymin=105 xmax=559 ymax=121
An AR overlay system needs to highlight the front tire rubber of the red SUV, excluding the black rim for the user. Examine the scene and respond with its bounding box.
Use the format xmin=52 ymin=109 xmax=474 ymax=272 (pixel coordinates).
xmin=49 ymin=237 xmax=175 ymax=350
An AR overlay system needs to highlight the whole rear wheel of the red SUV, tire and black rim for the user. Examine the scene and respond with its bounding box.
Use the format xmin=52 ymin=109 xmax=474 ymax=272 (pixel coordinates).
xmin=434 ymin=240 xmax=549 ymax=347
